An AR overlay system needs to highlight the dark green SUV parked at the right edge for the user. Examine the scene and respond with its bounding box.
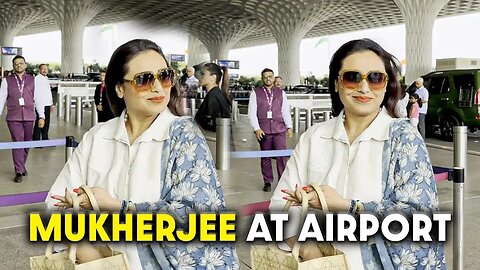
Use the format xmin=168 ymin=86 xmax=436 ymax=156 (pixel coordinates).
xmin=416 ymin=69 xmax=480 ymax=140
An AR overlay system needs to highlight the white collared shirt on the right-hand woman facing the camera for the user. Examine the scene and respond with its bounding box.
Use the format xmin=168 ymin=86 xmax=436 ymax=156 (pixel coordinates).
xmin=270 ymin=109 xmax=394 ymax=269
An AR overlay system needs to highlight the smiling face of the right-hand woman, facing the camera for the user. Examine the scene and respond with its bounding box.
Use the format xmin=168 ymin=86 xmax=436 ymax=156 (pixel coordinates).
xmin=336 ymin=51 xmax=387 ymax=116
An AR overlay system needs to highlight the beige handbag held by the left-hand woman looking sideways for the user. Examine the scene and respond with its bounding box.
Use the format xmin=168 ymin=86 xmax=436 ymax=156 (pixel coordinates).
xmin=30 ymin=186 xmax=130 ymax=270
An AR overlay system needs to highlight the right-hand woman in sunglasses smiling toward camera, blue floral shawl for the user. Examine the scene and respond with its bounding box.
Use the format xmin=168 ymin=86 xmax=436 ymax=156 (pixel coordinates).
xmin=270 ymin=39 xmax=446 ymax=269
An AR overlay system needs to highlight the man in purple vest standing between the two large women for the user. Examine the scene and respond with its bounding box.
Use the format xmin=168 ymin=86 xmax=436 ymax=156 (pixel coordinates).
xmin=248 ymin=68 xmax=292 ymax=192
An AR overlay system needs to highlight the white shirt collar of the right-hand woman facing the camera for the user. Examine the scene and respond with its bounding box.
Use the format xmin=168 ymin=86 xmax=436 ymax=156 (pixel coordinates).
xmin=330 ymin=108 xmax=394 ymax=143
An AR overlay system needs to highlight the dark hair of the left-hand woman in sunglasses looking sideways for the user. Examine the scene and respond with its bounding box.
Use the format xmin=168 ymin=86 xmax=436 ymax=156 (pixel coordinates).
xmin=105 ymin=39 xmax=181 ymax=116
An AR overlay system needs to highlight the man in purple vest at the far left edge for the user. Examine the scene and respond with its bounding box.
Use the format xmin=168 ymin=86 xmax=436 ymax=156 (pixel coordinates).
xmin=0 ymin=55 xmax=45 ymax=183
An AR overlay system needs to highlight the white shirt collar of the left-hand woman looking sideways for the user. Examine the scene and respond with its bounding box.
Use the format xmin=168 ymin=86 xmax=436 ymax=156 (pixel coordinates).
xmin=104 ymin=108 xmax=177 ymax=144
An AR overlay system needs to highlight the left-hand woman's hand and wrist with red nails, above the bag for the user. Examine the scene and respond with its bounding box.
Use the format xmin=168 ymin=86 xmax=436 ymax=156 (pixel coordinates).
xmin=52 ymin=187 xmax=121 ymax=211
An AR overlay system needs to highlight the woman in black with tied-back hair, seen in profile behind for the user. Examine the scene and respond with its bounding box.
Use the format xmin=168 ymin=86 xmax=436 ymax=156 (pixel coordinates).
xmin=195 ymin=63 xmax=231 ymax=132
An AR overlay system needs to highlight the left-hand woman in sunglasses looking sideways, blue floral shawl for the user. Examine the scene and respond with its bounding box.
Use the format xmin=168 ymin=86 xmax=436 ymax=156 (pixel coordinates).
xmin=46 ymin=40 xmax=238 ymax=269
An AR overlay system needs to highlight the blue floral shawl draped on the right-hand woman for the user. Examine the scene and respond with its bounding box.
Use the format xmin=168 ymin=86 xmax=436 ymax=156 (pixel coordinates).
xmin=362 ymin=120 xmax=446 ymax=270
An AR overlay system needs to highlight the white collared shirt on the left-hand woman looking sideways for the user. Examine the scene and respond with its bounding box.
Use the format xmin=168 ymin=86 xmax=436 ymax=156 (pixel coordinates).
xmin=45 ymin=108 xmax=178 ymax=269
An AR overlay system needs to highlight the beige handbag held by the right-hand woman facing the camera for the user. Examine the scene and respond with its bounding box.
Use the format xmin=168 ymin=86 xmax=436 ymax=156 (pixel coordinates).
xmin=250 ymin=185 xmax=349 ymax=270
